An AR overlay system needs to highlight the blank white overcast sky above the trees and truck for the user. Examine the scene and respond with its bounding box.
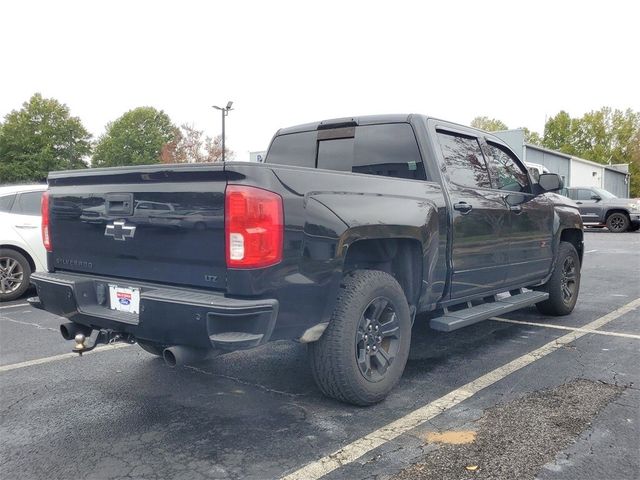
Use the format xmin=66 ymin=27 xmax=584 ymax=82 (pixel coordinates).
xmin=0 ymin=0 xmax=640 ymax=160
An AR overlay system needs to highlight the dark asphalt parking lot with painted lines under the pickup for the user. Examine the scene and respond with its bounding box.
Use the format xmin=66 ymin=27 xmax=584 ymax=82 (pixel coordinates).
xmin=0 ymin=230 xmax=640 ymax=480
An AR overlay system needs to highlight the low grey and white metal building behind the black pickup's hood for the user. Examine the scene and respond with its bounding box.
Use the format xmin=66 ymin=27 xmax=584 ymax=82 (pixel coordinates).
xmin=493 ymin=129 xmax=629 ymax=198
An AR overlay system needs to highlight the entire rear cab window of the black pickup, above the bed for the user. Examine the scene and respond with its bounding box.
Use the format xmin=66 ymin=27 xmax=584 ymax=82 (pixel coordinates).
xmin=266 ymin=123 xmax=427 ymax=180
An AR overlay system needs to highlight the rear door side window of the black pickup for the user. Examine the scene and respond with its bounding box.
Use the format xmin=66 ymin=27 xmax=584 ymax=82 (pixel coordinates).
xmin=438 ymin=130 xmax=491 ymax=188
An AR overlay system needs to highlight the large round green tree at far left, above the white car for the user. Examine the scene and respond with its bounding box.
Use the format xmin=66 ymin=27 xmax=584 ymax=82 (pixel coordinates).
xmin=0 ymin=93 xmax=91 ymax=183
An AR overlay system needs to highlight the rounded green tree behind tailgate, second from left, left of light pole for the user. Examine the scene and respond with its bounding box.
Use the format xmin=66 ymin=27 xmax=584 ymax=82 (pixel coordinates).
xmin=92 ymin=107 xmax=180 ymax=167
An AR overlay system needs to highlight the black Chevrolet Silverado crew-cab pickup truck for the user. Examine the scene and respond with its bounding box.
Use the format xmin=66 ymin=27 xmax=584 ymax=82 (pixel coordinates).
xmin=31 ymin=115 xmax=583 ymax=405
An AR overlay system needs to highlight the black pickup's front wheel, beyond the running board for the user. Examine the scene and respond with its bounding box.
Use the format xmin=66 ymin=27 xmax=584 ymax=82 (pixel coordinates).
xmin=536 ymin=242 xmax=580 ymax=316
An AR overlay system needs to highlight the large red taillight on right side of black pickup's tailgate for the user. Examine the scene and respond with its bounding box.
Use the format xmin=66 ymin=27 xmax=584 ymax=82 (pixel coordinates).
xmin=224 ymin=185 xmax=284 ymax=268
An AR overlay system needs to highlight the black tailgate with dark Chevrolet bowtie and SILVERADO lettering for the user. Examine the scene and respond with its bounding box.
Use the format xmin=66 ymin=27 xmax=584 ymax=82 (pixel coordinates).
xmin=49 ymin=165 xmax=227 ymax=290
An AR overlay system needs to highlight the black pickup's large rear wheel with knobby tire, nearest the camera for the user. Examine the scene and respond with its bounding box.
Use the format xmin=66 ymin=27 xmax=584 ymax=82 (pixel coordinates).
xmin=308 ymin=270 xmax=411 ymax=406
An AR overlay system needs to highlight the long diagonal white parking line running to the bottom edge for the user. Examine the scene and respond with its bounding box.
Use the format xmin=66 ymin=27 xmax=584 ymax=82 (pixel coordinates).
xmin=282 ymin=298 xmax=640 ymax=480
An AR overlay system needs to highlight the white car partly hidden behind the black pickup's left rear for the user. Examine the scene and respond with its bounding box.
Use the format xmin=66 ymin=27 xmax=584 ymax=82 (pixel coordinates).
xmin=0 ymin=185 xmax=47 ymax=302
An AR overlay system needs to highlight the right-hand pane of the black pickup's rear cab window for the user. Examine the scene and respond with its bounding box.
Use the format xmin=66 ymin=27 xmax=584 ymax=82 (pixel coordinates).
xmin=352 ymin=123 xmax=426 ymax=180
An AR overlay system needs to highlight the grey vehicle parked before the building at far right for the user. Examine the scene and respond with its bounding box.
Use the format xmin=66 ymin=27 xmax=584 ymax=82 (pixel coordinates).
xmin=560 ymin=187 xmax=640 ymax=233
